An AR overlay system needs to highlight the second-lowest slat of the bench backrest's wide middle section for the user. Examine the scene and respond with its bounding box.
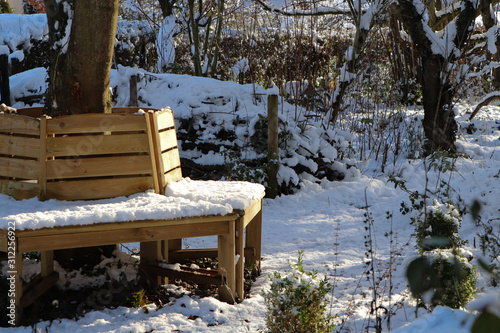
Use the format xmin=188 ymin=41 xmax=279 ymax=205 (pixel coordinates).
xmin=47 ymin=155 xmax=153 ymax=180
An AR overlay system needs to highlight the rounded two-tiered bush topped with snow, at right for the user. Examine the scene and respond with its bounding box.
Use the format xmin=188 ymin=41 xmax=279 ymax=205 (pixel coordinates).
xmin=407 ymin=199 xmax=476 ymax=309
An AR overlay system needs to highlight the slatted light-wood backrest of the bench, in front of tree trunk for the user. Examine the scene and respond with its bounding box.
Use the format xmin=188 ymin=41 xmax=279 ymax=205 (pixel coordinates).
xmin=0 ymin=108 xmax=182 ymax=200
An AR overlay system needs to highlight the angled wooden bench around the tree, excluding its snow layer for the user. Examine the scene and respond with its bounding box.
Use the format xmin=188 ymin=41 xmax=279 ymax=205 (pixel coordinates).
xmin=0 ymin=108 xmax=264 ymax=319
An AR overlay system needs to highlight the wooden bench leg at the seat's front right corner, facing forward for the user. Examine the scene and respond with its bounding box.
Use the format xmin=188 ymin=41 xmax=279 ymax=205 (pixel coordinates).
xmin=218 ymin=221 xmax=236 ymax=303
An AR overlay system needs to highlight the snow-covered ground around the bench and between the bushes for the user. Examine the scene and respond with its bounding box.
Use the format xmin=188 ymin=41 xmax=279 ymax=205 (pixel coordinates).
xmin=1 ymin=65 xmax=500 ymax=333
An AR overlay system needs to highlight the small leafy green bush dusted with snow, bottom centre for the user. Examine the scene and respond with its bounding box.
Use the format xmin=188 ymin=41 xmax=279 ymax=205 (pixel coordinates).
xmin=264 ymin=251 xmax=334 ymax=333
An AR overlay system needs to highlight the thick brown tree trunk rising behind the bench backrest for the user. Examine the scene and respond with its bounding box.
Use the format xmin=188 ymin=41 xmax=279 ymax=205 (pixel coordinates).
xmin=46 ymin=0 xmax=119 ymax=116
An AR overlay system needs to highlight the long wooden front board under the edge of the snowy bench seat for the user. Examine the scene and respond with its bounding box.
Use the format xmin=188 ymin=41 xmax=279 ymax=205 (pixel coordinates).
xmin=18 ymin=222 xmax=234 ymax=252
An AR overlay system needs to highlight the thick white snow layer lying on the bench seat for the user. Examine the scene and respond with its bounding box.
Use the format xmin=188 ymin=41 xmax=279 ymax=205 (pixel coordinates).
xmin=0 ymin=179 xmax=264 ymax=230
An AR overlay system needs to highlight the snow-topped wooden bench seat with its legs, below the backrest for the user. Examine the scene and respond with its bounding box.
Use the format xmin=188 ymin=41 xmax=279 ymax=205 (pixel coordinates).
xmin=0 ymin=179 xmax=264 ymax=322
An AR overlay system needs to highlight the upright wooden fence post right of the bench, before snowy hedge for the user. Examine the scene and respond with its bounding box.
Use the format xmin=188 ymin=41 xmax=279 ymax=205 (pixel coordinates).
xmin=267 ymin=95 xmax=279 ymax=199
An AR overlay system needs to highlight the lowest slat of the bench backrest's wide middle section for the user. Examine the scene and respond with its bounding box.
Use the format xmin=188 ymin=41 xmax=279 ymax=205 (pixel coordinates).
xmin=47 ymin=176 xmax=153 ymax=200
